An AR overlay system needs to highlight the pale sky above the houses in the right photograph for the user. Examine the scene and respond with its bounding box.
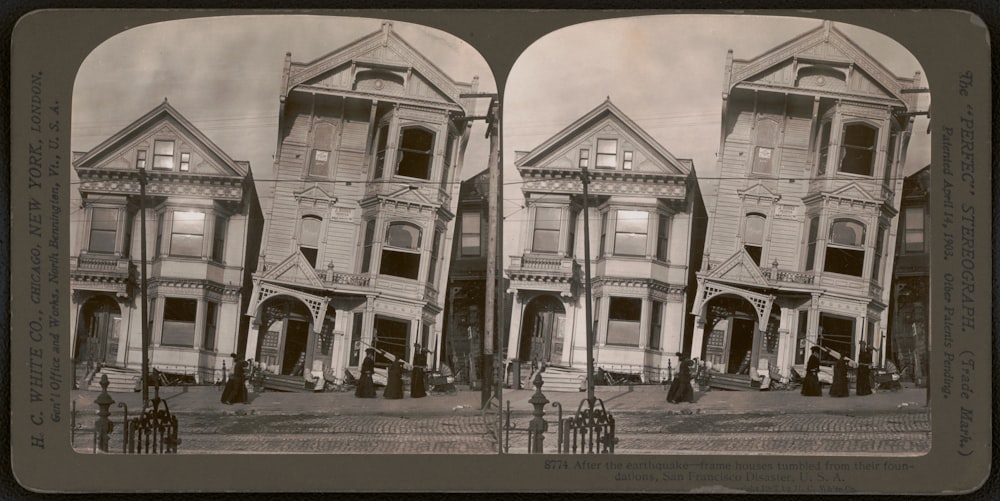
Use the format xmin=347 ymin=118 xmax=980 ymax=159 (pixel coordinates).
xmin=503 ymin=14 xmax=930 ymax=258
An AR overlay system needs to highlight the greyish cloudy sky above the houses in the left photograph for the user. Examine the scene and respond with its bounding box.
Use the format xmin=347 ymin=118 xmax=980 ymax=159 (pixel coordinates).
xmin=71 ymin=15 xmax=496 ymax=191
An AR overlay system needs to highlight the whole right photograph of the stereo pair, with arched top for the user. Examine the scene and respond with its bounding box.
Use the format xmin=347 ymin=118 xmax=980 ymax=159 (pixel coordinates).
xmin=501 ymin=15 xmax=932 ymax=456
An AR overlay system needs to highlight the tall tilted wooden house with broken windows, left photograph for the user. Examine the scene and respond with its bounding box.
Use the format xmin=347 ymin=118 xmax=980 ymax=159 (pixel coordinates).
xmin=246 ymin=23 xmax=478 ymax=381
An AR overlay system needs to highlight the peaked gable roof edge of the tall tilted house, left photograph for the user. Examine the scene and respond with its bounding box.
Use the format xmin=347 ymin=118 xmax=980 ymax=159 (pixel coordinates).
xmin=282 ymin=21 xmax=478 ymax=113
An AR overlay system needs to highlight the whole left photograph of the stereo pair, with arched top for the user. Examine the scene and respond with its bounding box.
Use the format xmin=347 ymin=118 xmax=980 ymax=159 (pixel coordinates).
xmin=69 ymin=16 xmax=496 ymax=454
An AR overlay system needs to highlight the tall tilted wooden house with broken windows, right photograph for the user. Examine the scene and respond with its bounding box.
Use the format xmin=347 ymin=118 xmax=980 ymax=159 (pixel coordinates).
xmin=691 ymin=22 xmax=920 ymax=378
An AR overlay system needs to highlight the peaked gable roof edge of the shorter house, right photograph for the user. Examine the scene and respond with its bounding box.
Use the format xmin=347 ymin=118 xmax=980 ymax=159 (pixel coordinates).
xmin=514 ymin=97 xmax=692 ymax=175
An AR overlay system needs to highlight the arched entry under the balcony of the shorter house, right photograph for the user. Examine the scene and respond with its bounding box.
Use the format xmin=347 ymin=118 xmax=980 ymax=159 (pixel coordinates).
xmin=518 ymin=295 xmax=566 ymax=364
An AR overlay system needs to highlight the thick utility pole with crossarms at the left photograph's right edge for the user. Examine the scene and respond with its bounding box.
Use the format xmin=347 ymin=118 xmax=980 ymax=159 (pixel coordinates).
xmin=459 ymin=93 xmax=503 ymax=409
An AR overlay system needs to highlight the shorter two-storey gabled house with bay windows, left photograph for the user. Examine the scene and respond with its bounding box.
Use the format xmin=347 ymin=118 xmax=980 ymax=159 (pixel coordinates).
xmin=69 ymin=100 xmax=263 ymax=382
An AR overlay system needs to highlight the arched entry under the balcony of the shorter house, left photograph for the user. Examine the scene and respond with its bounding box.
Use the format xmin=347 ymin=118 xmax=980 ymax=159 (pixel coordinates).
xmin=73 ymin=294 xmax=122 ymax=365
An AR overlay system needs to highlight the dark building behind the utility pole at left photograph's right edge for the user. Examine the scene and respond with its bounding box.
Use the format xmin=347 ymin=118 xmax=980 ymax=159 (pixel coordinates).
xmin=440 ymin=170 xmax=490 ymax=378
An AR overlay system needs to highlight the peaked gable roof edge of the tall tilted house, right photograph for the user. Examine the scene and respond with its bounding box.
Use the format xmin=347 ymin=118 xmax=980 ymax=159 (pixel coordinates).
xmin=725 ymin=21 xmax=920 ymax=108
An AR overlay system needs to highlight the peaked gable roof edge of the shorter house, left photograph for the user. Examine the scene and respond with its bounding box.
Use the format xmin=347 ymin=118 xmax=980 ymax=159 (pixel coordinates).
xmin=73 ymin=98 xmax=250 ymax=177
